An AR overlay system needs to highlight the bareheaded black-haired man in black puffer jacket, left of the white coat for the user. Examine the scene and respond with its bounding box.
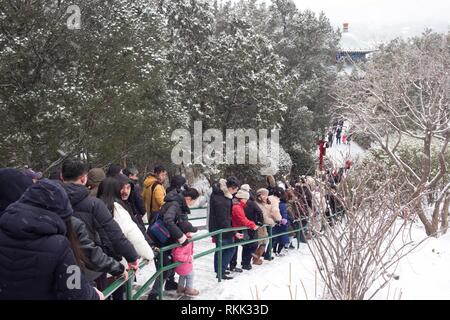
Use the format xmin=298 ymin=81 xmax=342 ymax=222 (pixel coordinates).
xmin=62 ymin=160 xmax=139 ymax=289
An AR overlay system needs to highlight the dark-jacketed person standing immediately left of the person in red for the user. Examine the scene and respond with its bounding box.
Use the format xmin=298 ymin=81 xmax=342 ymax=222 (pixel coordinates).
xmin=208 ymin=177 xmax=240 ymax=280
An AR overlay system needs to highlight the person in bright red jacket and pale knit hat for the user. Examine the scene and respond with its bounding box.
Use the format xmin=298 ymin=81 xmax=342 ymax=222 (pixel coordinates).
xmin=230 ymin=184 xmax=258 ymax=272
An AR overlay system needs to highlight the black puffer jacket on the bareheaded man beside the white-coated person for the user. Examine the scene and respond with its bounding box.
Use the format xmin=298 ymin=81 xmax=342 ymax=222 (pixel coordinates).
xmin=64 ymin=183 xmax=139 ymax=262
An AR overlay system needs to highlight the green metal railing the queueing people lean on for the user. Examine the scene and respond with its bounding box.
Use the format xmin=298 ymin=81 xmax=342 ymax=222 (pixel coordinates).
xmin=103 ymin=223 xmax=306 ymax=300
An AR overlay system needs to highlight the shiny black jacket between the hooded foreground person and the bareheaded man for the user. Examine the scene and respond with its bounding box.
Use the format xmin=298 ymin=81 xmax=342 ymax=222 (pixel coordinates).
xmin=71 ymin=216 xmax=125 ymax=281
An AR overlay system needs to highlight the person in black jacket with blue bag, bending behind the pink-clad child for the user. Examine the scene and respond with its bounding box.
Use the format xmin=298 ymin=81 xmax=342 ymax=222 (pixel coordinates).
xmin=148 ymin=188 xmax=199 ymax=300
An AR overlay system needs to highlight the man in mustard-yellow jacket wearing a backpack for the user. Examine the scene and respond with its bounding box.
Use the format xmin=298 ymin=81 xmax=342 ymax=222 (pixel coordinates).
xmin=142 ymin=166 xmax=167 ymax=224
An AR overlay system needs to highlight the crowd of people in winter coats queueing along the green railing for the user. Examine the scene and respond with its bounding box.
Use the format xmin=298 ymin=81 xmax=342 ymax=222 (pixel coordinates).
xmin=0 ymin=160 xmax=348 ymax=300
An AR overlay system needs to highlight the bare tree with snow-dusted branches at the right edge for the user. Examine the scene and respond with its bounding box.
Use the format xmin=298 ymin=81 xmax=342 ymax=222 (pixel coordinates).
xmin=336 ymin=30 xmax=450 ymax=235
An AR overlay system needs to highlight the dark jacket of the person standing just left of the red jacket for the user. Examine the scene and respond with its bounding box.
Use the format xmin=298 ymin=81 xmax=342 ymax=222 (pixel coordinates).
xmin=208 ymin=179 xmax=236 ymax=239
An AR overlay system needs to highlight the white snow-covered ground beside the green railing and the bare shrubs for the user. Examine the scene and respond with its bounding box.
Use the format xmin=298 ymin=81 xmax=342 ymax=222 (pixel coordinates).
xmin=133 ymin=142 xmax=450 ymax=300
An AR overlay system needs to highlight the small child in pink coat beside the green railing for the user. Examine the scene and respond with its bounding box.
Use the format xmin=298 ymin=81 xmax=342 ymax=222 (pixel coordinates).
xmin=172 ymin=221 xmax=200 ymax=296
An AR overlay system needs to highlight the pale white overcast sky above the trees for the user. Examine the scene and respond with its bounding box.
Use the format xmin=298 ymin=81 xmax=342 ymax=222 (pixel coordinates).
xmin=248 ymin=0 xmax=450 ymax=41
